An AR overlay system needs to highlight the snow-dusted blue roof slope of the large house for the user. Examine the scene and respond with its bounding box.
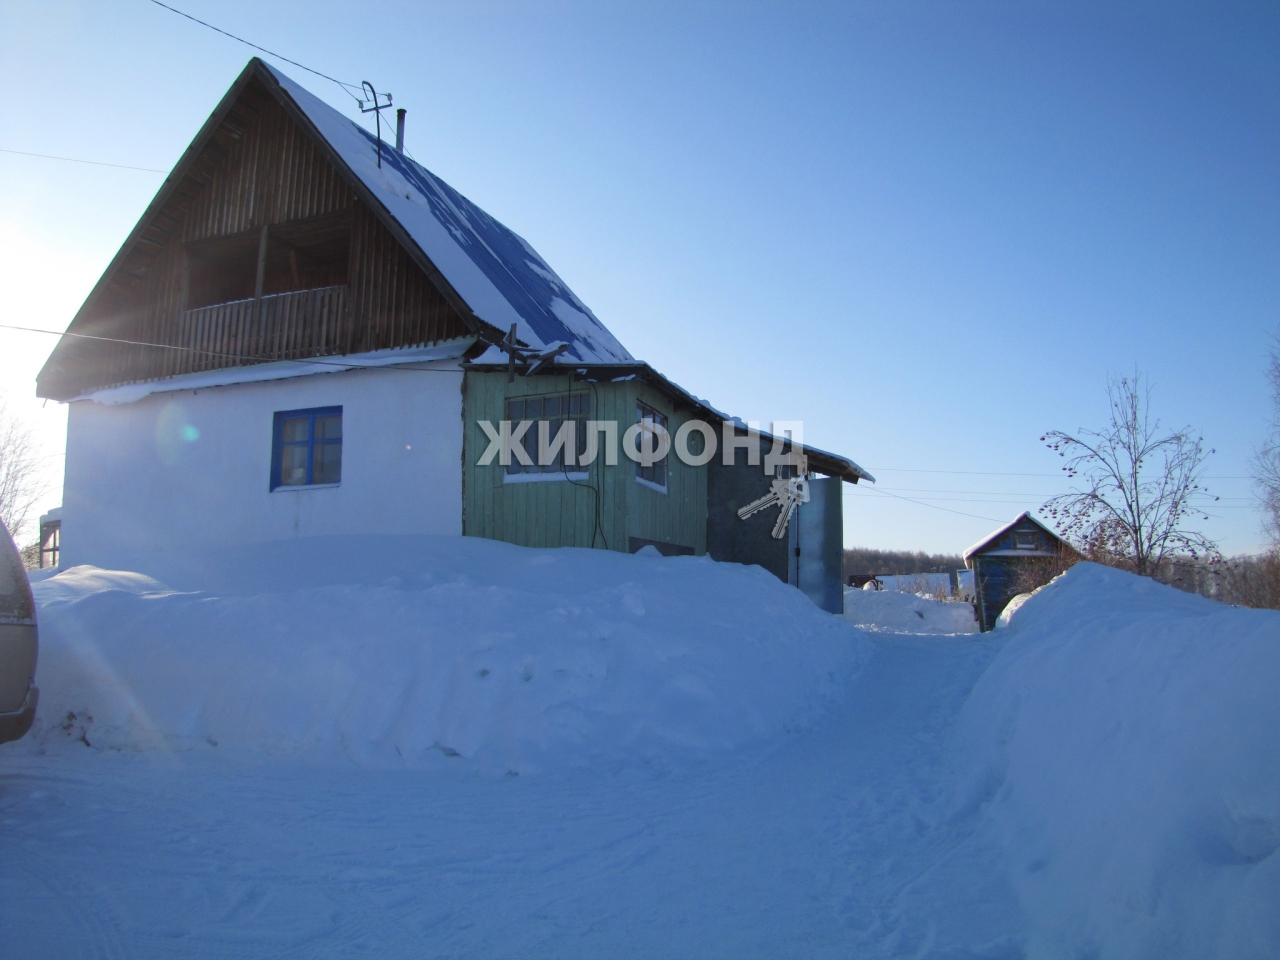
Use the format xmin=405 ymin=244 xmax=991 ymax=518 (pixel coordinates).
xmin=264 ymin=64 xmax=634 ymax=364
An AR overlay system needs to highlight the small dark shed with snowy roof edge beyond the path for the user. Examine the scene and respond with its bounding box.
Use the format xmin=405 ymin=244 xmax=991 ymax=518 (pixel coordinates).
xmin=964 ymin=512 xmax=1075 ymax=630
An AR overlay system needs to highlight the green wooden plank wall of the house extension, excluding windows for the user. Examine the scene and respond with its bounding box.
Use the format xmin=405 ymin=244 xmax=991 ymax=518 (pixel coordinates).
xmin=462 ymin=370 xmax=707 ymax=554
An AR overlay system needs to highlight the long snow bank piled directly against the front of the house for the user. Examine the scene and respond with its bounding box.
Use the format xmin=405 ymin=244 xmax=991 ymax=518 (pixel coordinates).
xmin=24 ymin=538 xmax=868 ymax=772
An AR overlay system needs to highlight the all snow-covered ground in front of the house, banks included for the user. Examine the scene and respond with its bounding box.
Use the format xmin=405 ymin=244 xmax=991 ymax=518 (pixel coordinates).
xmin=0 ymin=539 xmax=1280 ymax=960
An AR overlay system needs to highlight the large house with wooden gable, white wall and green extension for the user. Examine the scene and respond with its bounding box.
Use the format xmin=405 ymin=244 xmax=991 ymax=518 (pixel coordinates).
xmin=37 ymin=59 xmax=873 ymax=607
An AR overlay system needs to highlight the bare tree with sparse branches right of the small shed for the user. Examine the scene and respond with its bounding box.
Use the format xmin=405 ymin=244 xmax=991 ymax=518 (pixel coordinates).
xmin=1041 ymin=372 xmax=1219 ymax=575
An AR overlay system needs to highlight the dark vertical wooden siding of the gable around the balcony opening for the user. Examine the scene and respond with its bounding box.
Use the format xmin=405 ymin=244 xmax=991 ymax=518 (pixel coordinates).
xmin=40 ymin=76 xmax=470 ymax=398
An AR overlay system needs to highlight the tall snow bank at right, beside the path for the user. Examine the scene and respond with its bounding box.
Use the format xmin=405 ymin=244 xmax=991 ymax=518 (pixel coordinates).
xmin=957 ymin=563 xmax=1280 ymax=959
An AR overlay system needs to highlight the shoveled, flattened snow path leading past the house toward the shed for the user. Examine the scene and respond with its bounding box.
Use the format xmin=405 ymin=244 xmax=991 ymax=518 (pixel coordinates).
xmin=0 ymin=635 xmax=1021 ymax=960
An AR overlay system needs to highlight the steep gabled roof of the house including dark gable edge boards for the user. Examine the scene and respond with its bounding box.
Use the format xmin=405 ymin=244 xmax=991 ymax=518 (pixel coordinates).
xmin=37 ymin=58 xmax=632 ymax=399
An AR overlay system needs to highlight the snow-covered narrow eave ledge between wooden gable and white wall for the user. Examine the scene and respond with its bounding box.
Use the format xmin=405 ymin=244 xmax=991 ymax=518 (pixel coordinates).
xmin=68 ymin=337 xmax=476 ymax=406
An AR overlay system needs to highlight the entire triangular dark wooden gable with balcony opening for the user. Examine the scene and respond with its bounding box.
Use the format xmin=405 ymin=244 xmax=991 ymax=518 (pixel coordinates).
xmin=37 ymin=61 xmax=476 ymax=399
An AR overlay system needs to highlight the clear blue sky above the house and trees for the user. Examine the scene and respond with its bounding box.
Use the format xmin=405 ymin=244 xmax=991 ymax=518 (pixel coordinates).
xmin=0 ymin=0 xmax=1280 ymax=552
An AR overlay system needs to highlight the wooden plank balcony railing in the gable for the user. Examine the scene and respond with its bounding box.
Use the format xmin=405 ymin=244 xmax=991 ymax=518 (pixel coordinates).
xmin=174 ymin=285 xmax=347 ymax=372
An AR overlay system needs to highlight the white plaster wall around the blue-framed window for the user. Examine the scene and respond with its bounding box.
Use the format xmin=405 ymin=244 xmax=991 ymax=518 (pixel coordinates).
xmin=61 ymin=369 xmax=462 ymax=568
